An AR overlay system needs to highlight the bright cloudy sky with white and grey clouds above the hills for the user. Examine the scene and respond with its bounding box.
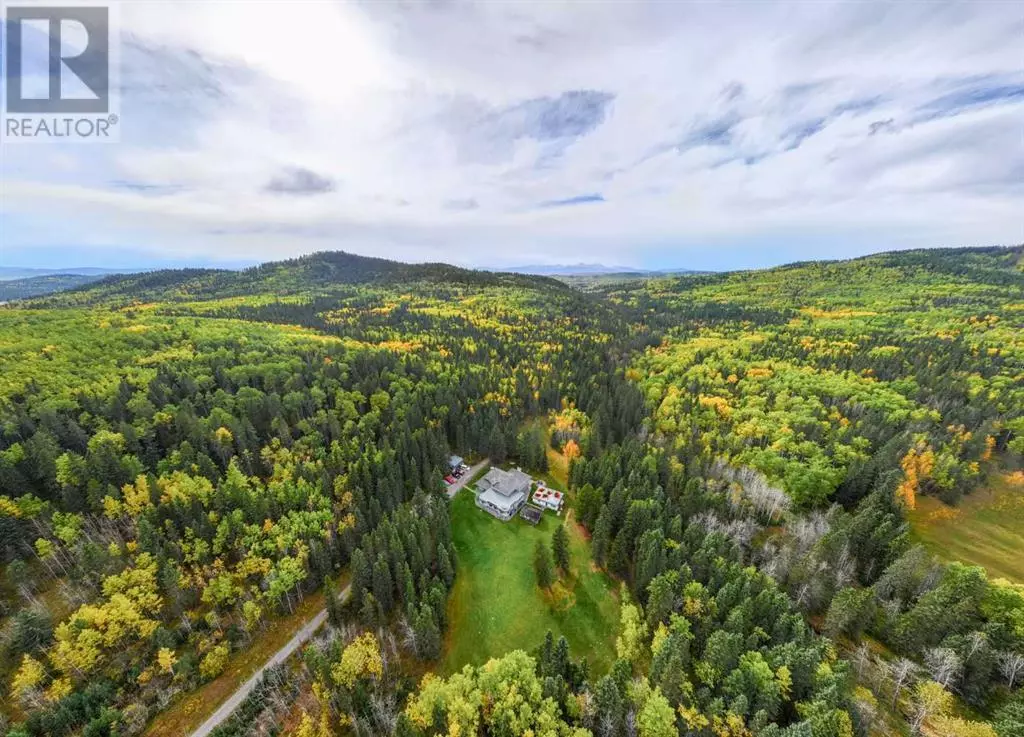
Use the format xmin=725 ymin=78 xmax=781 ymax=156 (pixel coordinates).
xmin=0 ymin=0 xmax=1024 ymax=269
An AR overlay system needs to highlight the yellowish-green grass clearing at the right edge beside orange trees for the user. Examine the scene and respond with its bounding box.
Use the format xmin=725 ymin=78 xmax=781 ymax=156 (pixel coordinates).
xmin=909 ymin=471 xmax=1024 ymax=583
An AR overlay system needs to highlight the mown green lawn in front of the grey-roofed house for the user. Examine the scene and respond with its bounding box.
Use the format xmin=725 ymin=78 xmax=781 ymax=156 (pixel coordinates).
xmin=441 ymin=489 xmax=618 ymax=674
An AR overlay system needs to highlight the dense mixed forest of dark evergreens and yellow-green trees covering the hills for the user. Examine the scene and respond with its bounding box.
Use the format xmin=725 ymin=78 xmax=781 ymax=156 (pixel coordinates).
xmin=0 ymin=247 xmax=1024 ymax=737
